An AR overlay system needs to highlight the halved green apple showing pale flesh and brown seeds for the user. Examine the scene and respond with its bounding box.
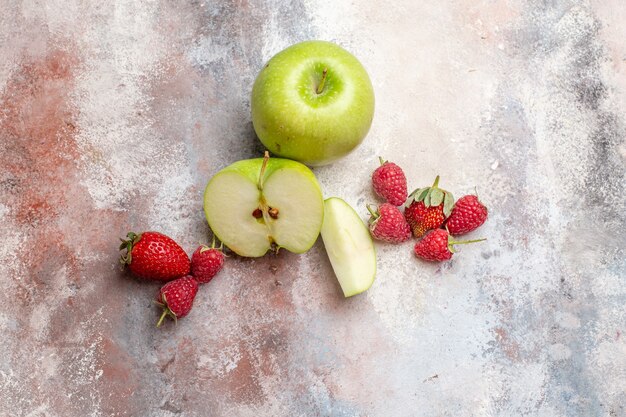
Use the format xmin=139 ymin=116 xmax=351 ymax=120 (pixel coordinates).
xmin=204 ymin=153 xmax=324 ymax=257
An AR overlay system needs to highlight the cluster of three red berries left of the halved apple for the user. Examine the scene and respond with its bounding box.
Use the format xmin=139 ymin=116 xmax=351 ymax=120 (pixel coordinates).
xmin=120 ymin=232 xmax=224 ymax=327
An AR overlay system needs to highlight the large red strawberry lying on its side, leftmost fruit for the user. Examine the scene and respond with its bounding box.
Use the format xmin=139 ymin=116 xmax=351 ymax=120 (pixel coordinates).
xmin=120 ymin=232 xmax=190 ymax=281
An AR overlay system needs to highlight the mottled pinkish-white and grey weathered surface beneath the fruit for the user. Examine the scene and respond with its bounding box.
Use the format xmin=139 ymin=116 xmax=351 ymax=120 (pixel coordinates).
xmin=0 ymin=0 xmax=626 ymax=417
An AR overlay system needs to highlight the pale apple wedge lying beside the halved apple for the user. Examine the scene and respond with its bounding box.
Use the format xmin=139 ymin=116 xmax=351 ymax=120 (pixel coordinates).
xmin=321 ymin=197 xmax=376 ymax=297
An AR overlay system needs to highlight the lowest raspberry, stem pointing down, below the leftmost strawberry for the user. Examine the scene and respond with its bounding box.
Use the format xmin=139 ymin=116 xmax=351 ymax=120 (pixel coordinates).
xmin=156 ymin=275 xmax=198 ymax=327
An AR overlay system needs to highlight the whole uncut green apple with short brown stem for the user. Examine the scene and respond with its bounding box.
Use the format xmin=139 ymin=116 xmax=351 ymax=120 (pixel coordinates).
xmin=251 ymin=41 xmax=374 ymax=166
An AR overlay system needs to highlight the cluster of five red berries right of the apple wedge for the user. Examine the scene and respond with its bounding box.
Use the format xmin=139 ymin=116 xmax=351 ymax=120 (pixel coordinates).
xmin=367 ymin=158 xmax=488 ymax=262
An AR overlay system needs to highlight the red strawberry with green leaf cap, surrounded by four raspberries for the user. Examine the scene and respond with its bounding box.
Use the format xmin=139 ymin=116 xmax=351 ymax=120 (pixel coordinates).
xmin=404 ymin=175 xmax=454 ymax=238
